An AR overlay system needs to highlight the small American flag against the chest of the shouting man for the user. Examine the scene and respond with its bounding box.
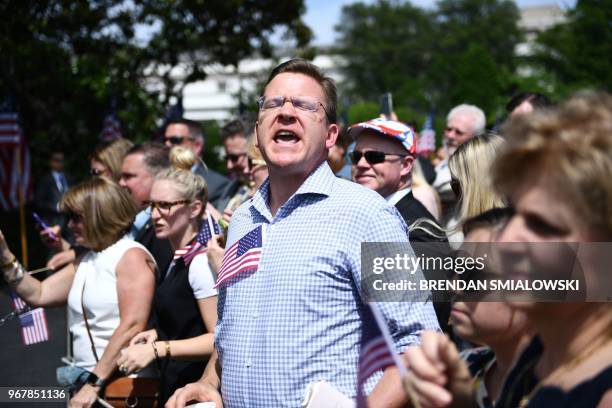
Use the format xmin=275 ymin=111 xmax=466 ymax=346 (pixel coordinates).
xmin=215 ymin=225 xmax=263 ymax=288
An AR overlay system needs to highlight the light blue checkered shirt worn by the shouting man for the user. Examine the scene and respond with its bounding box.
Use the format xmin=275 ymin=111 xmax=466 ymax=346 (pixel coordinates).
xmin=216 ymin=162 xmax=438 ymax=408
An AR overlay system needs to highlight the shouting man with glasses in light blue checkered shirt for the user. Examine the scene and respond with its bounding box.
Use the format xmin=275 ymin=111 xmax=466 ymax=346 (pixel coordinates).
xmin=167 ymin=59 xmax=438 ymax=408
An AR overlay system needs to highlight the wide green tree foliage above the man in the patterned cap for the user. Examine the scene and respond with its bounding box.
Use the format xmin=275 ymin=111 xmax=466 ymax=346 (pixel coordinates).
xmin=337 ymin=0 xmax=522 ymax=124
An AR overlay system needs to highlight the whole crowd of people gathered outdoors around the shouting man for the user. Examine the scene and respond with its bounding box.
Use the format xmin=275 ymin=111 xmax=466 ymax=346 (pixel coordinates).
xmin=0 ymin=59 xmax=612 ymax=408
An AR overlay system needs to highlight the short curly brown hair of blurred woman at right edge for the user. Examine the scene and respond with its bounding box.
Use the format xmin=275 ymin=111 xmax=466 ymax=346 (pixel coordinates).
xmin=493 ymin=92 xmax=612 ymax=234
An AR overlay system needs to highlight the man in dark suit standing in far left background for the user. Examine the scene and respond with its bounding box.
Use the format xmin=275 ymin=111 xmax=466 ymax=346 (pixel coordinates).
xmin=34 ymin=152 xmax=72 ymax=232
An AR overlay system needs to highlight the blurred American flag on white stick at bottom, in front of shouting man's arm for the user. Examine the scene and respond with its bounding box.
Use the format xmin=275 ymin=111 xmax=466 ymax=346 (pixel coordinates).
xmin=357 ymin=303 xmax=406 ymax=408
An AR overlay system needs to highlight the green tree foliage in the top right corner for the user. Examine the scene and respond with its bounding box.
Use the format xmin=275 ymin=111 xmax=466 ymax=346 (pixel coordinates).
xmin=533 ymin=0 xmax=612 ymax=96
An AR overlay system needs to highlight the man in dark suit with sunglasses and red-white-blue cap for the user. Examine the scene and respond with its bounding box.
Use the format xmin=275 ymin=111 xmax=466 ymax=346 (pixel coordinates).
xmin=349 ymin=118 xmax=450 ymax=331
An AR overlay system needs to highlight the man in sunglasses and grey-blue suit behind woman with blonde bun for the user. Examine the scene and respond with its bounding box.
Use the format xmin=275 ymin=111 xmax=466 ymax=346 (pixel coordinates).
xmin=164 ymin=119 xmax=229 ymax=207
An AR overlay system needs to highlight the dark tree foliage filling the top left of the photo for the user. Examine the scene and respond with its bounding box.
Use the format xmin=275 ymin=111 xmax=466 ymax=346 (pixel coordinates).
xmin=0 ymin=0 xmax=311 ymax=177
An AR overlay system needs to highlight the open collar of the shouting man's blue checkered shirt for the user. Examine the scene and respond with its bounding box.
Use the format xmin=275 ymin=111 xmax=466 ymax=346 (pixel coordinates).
xmin=251 ymin=161 xmax=336 ymax=220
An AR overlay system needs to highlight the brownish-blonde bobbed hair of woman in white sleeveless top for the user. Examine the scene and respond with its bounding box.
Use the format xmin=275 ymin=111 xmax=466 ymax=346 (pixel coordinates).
xmin=60 ymin=177 xmax=139 ymax=252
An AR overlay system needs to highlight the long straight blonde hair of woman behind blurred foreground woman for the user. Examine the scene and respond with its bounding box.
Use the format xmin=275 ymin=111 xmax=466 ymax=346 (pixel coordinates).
xmin=448 ymin=133 xmax=505 ymax=222
